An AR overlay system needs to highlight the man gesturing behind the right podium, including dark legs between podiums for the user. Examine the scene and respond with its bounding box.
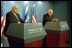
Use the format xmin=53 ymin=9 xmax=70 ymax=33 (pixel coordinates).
xmin=42 ymin=9 xmax=59 ymax=47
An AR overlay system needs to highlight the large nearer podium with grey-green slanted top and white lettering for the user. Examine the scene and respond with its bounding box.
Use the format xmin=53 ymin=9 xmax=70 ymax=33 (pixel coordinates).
xmin=6 ymin=23 xmax=46 ymax=47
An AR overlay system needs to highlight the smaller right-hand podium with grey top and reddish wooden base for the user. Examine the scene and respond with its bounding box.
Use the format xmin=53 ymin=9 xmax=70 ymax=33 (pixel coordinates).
xmin=44 ymin=21 xmax=69 ymax=47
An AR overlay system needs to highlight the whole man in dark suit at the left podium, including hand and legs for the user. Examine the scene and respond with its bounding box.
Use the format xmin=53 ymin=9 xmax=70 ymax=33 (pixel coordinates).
xmin=4 ymin=5 xmax=28 ymax=47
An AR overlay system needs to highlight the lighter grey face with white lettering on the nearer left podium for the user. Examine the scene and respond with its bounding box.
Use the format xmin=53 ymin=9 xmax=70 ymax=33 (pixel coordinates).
xmin=24 ymin=23 xmax=46 ymax=44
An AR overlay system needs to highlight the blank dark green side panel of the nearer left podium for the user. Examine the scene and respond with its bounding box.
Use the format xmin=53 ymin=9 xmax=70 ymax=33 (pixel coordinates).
xmin=6 ymin=23 xmax=24 ymax=39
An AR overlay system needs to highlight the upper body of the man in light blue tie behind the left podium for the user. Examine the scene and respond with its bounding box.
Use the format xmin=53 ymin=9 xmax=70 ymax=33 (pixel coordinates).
xmin=4 ymin=5 xmax=24 ymax=34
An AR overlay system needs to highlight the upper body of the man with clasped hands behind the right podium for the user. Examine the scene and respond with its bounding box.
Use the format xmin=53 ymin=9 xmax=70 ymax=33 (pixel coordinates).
xmin=42 ymin=9 xmax=59 ymax=26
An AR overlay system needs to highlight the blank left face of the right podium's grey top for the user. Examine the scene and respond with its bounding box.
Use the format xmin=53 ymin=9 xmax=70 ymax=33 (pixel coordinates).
xmin=44 ymin=22 xmax=60 ymax=31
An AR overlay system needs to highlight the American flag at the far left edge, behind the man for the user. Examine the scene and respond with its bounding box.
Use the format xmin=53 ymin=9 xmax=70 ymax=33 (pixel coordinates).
xmin=1 ymin=1 xmax=6 ymax=46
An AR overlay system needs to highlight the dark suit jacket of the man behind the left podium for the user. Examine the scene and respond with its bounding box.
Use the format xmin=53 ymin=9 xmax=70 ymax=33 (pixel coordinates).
xmin=4 ymin=11 xmax=24 ymax=35
